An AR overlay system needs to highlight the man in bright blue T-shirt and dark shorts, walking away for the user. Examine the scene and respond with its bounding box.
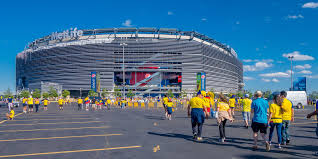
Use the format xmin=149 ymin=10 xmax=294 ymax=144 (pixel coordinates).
xmin=251 ymin=91 xmax=270 ymax=151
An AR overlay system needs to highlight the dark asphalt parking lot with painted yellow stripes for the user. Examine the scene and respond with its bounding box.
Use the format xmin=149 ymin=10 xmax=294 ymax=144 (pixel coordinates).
xmin=0 ymin=103 xmax=318 ymax=159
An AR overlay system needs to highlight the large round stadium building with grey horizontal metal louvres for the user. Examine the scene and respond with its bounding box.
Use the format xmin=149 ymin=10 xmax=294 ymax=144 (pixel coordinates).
xmin=16 ymin=28 xmax=243 ymax=96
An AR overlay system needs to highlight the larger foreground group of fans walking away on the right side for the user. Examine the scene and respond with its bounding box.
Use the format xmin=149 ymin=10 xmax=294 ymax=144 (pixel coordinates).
xmin=188 ymin=91 xmax=318 ymax=151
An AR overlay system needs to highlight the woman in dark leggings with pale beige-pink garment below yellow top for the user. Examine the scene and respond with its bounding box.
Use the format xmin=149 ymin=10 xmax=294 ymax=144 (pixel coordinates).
xmin=217 ymin=94 xmax=234 ymax=143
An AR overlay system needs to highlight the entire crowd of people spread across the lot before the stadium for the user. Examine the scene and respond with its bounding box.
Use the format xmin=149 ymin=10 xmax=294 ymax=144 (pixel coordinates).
xmin=1 ymin=91 xmax=318 ymax=154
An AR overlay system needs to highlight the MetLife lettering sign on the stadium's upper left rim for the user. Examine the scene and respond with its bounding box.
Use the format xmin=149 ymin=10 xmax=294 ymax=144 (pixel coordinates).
xmin=50 ymin=28 xmax=83 ymax=40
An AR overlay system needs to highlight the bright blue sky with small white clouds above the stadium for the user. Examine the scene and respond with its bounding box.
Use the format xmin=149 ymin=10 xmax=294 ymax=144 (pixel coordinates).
xmin=0 ymin=0 xmax=318 ymax=92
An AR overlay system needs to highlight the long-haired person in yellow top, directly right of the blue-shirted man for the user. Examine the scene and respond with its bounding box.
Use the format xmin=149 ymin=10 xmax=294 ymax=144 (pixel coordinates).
xmin=268 ymin=94 xmax=283 ymax=149
